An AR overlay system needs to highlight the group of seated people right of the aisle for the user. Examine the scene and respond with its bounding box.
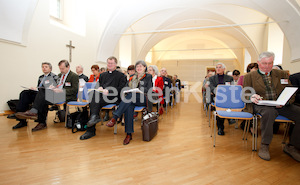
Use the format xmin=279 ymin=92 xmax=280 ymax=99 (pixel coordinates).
xmin=203 ymin=52 xmax=300 ymax=162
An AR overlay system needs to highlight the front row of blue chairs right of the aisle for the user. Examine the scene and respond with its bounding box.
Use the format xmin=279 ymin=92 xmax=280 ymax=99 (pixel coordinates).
xmin=204 ymin=85 xmax=294 ymax=151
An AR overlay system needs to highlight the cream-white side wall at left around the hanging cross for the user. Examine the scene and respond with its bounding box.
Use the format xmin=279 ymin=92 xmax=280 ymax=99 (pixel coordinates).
xmin=0 ymin=0 xmax=109 ymax=112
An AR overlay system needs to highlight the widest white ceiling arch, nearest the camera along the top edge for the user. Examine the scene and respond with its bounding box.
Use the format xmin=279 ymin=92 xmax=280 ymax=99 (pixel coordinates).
xmin=98 ymin=0 xmax=300 ymax=62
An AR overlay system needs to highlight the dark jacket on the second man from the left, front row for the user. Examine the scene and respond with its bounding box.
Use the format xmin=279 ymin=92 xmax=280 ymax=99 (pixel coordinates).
xmin=57 ymin=71 xmax=79 ymax=102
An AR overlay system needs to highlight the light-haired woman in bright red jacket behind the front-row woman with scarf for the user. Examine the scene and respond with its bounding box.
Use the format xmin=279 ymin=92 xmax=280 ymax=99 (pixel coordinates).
xmin=148 ymin=65 xmax=164 ymax=111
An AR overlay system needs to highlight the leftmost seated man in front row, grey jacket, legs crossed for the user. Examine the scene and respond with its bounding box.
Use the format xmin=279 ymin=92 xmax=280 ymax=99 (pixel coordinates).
xmin=13 ymin=62 xmax=57 ymax=129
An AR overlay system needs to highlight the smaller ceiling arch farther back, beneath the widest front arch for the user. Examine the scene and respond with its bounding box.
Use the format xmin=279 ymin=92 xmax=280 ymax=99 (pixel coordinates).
xmin=125 ymin=5 xmax=272 ymax=64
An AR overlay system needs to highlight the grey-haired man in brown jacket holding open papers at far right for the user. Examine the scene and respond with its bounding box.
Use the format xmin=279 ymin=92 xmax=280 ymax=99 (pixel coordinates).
xmin=244 ymin=52 xmax=300 ymax=162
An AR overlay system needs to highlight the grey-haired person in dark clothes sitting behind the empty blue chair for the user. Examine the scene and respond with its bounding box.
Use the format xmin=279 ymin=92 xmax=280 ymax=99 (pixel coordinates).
xmin=207 ymin=63 xmax=233 ymax=136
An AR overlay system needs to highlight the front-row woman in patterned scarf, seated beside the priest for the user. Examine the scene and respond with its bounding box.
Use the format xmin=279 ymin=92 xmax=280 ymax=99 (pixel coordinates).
xmin=106 ymin=60 xmax=153 ymax=145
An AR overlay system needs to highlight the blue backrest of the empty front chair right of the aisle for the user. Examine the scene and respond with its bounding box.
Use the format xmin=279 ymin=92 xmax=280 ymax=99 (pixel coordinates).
xmin=215 ymin=85 xmax=245 ymax=109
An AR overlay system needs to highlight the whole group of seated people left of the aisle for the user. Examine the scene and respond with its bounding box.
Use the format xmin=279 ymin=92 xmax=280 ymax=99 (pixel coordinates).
xmin=9 ymin=57 xmax=181 ymax=145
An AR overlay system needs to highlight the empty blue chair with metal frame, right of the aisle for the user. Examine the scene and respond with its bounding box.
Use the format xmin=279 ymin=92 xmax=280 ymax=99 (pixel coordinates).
xmin=213 ymin=85 xmax=254 ymax=149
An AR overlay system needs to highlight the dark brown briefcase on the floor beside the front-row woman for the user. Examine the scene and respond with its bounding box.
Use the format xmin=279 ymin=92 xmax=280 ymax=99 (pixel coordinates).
xmin=142 ymin=109 xmax=158 ymax=141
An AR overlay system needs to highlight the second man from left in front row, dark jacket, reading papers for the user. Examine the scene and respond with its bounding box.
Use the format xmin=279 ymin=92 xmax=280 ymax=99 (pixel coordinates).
xmin=16 ymin=60 xmax=79 ymax=132
